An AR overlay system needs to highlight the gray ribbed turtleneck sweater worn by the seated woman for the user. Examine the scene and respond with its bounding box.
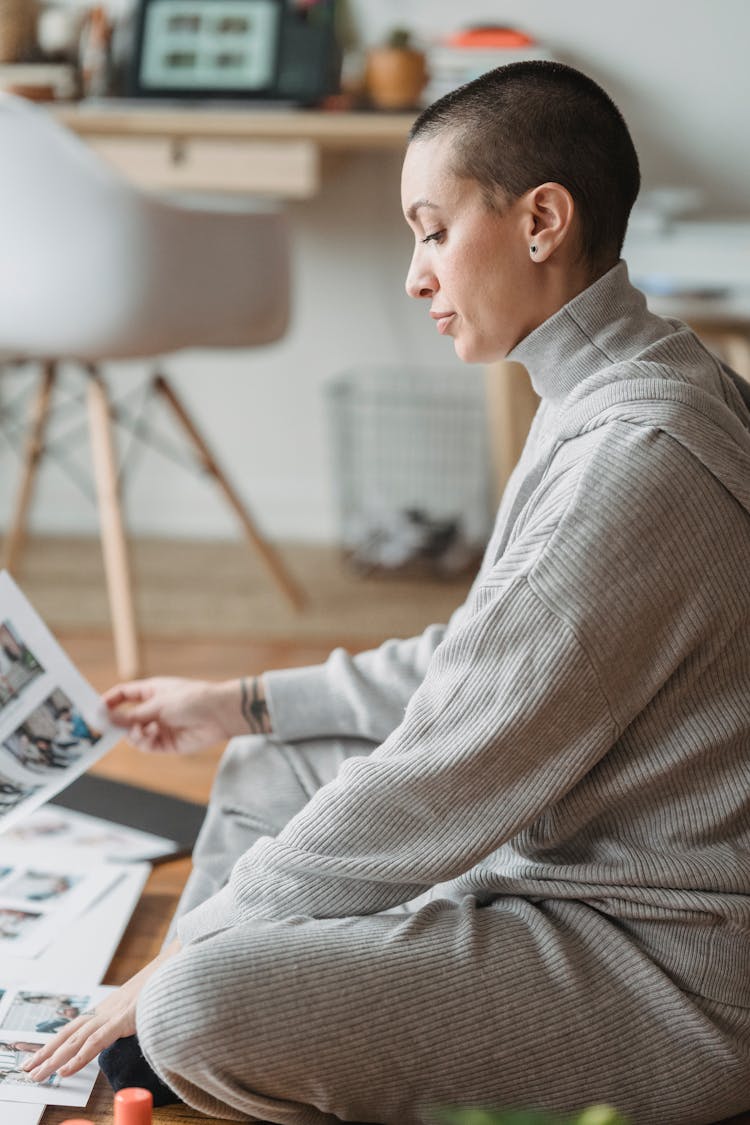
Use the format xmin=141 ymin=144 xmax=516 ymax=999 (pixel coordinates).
xmin=180 ymin=263 xmax=750 ymax=1005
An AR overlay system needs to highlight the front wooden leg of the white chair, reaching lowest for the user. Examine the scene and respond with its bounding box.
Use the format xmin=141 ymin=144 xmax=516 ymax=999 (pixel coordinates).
xmin=88 ymin=369 xmax=139 ymax=680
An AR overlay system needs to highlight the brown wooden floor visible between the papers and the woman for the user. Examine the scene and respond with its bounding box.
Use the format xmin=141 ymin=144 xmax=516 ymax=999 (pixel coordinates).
xmin=32 ymin=633 xmax=750 ymax=1125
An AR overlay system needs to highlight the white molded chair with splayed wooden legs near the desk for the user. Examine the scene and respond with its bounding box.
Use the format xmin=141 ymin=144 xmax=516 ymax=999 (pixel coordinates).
xmin=0 ymin=95 xmax=304 ymax=676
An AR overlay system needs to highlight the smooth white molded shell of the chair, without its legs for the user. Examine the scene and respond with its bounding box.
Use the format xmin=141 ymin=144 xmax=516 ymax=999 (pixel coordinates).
xmin=0 ymin=95 xmax=289 ymax=360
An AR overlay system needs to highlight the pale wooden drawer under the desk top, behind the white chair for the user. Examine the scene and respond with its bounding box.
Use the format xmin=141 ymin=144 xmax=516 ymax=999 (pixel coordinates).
xmin=89 ymin=136 xmax=320 ymax=199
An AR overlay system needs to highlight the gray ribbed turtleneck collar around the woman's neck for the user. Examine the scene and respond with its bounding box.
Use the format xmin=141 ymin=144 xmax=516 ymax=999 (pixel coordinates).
xmin=507 ymin=261 xmax=674 ymax=402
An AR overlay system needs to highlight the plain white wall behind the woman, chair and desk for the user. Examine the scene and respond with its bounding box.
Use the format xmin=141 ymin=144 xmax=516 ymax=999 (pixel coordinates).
xmin=0 ymin=0 xmax=750 ymax=539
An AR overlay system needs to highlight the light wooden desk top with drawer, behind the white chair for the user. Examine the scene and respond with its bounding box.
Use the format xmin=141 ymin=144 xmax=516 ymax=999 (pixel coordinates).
xmin=51 ymin=101 xmax=414 ymax=199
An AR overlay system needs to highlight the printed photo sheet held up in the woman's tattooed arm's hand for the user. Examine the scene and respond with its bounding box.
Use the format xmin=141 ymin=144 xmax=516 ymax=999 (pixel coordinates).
xmin=0 ymin=570 xmax=121 ymax=833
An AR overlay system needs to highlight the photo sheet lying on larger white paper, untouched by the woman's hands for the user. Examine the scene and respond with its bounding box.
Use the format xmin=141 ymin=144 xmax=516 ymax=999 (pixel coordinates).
xmin=0 ymin=837 xmax=121 ymax=957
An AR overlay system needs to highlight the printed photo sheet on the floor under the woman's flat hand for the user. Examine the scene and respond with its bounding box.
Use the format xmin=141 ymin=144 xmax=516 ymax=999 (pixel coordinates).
xmin=0 ymin=978 xmax=114 ymax=1102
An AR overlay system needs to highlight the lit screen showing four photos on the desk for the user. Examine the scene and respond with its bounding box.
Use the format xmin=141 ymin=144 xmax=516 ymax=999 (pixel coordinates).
xmin=139 ymin=0 xmax=281 ymax=92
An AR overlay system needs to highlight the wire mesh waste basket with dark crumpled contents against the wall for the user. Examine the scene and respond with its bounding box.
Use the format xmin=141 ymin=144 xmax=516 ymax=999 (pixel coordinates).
xmin=325 ymin=367 xmax=491 ymax=575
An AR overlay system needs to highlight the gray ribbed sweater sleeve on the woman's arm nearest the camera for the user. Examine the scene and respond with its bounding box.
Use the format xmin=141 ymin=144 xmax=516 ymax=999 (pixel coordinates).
xmin=180 ymin=576 xmax=614 ymax=942
